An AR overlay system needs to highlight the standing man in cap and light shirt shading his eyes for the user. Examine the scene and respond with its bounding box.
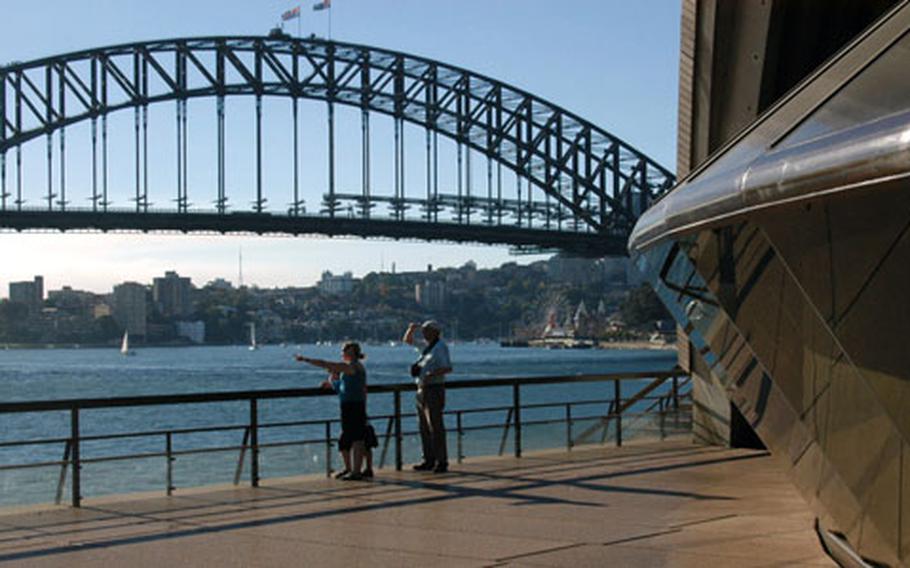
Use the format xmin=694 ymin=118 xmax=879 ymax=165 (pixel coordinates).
xmin=402 ymin=320 xmax=452 ymax=473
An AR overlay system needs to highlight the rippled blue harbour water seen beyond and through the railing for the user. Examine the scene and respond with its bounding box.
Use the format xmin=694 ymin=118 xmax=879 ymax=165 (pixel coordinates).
xmin=0 ymin=344 xmax=676 ymax=506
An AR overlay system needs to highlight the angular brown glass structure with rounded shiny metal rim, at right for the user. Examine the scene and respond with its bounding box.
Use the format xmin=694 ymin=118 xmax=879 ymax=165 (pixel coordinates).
xmin=629 ymin=2 xmax=910 ymax=566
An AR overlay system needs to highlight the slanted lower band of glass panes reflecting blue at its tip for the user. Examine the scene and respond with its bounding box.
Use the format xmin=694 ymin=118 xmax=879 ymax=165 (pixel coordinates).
xmin=638 ymin=224 xmax=900 ymax=562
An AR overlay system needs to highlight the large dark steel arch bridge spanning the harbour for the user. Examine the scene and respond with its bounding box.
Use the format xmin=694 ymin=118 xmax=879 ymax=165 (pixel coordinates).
xmin=0 ymin=36 xmax=674 ymax=256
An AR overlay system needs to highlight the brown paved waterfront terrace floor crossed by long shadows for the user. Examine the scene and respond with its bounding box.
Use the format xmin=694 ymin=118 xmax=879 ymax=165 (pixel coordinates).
xmin=0 ymin=442 xmax=833 ymax=568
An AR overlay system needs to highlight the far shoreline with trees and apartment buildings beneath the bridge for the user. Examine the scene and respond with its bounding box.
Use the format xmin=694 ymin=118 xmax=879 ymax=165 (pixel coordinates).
xmin=0 ymin=248 xmax=640 ymax=351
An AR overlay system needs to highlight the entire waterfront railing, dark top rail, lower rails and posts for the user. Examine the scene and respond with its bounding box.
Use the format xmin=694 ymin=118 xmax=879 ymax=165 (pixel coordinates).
xmin=0 ymin=367 xmax=687 ymax=507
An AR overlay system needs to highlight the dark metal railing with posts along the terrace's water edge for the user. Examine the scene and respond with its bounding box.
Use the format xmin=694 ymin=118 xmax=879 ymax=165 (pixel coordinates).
xmin=0 ymin=369 xmax=691 ymax=507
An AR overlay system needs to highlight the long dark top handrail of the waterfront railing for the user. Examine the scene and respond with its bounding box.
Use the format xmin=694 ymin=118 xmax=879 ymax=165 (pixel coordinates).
xmin=0 ymin=367 xmax=686 ymax=414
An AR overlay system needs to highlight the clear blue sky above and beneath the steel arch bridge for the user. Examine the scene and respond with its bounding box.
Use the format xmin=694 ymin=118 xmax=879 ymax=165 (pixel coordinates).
xmin=0 ymin=0 xmax=680 ymax=296
